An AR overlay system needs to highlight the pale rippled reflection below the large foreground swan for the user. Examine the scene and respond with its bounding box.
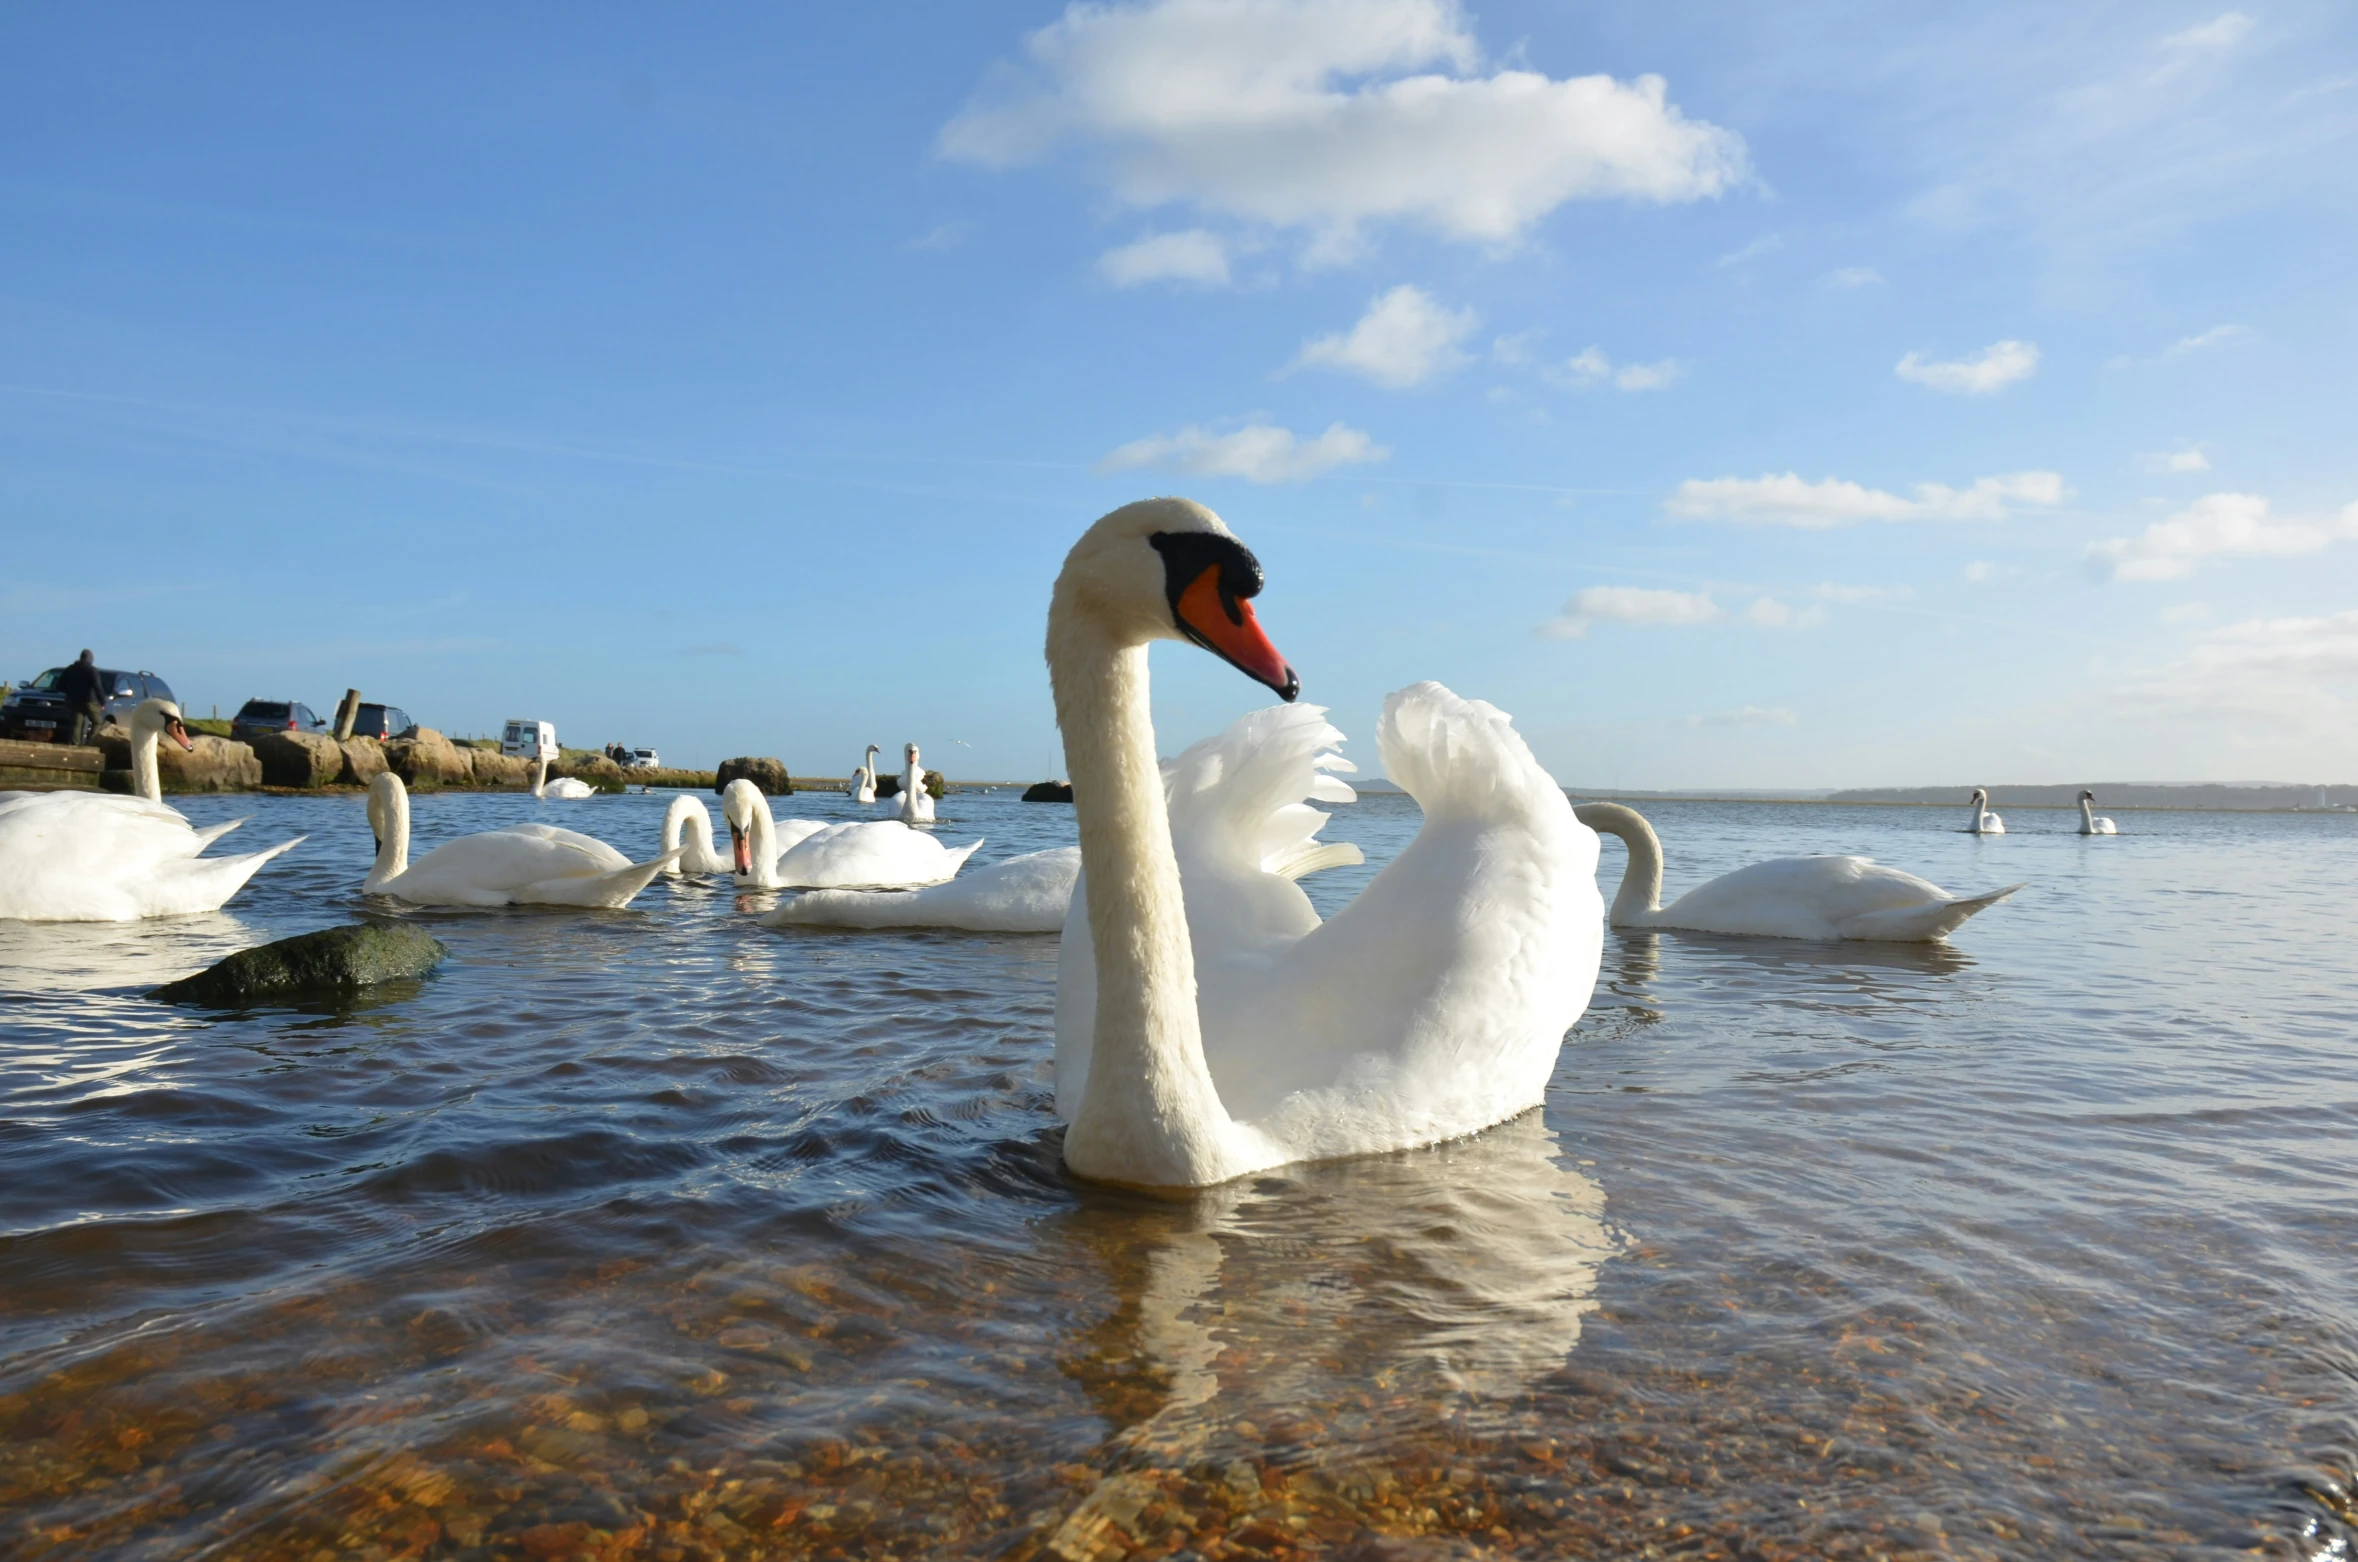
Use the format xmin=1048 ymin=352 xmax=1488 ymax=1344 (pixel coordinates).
xmin=1063 ymin=1109 xmax=1622 ymax=1463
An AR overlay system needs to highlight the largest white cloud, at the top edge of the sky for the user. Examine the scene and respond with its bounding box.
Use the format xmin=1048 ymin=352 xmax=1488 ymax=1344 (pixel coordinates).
xmin=938 ymin=0 xmax=1747 ymax=255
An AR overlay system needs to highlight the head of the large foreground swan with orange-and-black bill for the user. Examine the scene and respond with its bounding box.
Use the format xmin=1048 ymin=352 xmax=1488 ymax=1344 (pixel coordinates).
xmin=1056 ymin=498 xmax=1302 ymax=701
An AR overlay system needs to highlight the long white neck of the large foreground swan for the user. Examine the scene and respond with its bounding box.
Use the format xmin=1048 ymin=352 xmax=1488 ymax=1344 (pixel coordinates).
xmin=1047 ymin=613 xmax=1233 ymax=1187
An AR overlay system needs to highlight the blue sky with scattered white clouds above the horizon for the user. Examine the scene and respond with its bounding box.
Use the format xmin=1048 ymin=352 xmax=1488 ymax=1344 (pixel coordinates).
xmin=0 ymin=0 xmax=2358 ymax=788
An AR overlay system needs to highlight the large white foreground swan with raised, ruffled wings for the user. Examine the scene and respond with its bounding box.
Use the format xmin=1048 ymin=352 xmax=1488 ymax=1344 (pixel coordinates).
xmin=1047 ymin=500 xmax=1603 ymax=1187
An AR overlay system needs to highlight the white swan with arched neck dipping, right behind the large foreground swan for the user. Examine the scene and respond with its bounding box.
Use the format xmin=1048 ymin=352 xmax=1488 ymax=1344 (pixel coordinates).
xmin=1573 ymin=802 xmax=2021 ymax=944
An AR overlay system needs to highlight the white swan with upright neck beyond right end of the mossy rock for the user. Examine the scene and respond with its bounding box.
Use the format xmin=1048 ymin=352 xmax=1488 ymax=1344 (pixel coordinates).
xmin=361 ymin=772 xmax=677 ymax=908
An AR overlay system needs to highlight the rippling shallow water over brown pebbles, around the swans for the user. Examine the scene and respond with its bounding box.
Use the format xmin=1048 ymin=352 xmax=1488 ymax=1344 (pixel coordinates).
xmin=0 ymin=793 xmax=2358 ymax=1560
